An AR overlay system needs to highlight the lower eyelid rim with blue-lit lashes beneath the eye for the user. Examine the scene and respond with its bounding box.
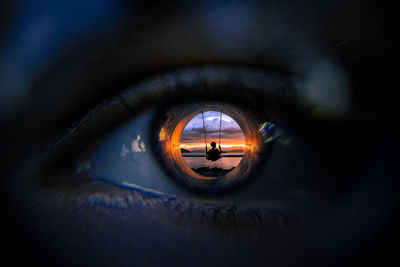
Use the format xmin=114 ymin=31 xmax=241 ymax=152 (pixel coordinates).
xmin=50 ymin=177 xmax=304 ymax=238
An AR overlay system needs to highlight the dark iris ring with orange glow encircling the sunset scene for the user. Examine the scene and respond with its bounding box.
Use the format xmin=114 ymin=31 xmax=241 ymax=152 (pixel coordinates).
xmin=158 ymin=102 xmax=264 ymax=193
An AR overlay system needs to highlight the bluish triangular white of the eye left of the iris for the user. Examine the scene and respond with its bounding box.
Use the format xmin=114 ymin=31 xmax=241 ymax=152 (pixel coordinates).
xmin=75 ymin=111 xmax=192 ymax=197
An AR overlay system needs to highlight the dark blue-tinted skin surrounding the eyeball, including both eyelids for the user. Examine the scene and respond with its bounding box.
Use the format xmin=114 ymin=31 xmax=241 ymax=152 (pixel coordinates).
xmin=0 ymin=0 xmax=400 ymax=266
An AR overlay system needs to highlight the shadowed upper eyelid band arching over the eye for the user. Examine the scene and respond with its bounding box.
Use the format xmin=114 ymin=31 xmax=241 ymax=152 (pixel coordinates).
xmin=53 ymin=66 xmax=354 ymax=153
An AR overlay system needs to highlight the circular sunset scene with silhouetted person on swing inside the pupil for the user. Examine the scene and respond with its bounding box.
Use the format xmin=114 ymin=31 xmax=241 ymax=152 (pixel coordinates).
xmin=180 ymin=110 xmax=245 ymax=177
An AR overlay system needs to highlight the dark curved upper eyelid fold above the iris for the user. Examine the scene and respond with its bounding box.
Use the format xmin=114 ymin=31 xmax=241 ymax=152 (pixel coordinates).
xmin=60 ymin=67 xmax=295 ymax=141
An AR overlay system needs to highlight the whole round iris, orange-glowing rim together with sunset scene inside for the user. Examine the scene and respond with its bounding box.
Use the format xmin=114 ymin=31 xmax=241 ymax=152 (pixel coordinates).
xmin=157 ymin=103 xmax=274 ymax=193
